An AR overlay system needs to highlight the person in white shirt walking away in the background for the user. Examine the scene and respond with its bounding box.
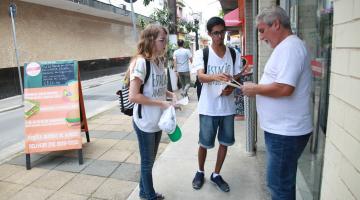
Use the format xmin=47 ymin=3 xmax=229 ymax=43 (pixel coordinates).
xmin=173 ymin=40 xmax=192 ymax=96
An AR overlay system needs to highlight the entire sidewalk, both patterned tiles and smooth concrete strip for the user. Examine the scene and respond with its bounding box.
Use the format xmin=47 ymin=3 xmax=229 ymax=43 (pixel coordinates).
xmin=0 ymin=89 xmax=266 ymax=200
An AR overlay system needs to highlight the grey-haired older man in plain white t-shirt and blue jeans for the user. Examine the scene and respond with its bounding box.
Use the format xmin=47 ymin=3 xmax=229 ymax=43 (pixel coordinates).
xmin=242 ymin=7 xmax=313 ymax=200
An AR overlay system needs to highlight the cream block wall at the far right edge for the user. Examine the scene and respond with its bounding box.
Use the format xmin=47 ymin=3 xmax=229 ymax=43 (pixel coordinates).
xmin=321 ymin=0 xmax=360 ymax=200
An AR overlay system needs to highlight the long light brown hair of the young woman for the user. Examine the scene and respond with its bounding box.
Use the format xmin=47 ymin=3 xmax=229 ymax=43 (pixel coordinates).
xmin=137 ymin=24 xmax=168 ymax=59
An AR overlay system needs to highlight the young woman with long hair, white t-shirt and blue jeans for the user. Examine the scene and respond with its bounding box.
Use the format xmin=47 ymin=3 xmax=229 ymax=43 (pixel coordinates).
xmin=129 ymin=25 xmax=176 ymax=200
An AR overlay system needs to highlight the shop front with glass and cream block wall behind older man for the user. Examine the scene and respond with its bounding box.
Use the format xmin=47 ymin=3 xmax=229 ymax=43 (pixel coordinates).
xmin=226 ymin=0 xmax=360 ymax=200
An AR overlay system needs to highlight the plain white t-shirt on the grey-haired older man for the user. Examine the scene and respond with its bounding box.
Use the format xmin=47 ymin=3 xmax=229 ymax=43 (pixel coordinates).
xmin=256 ymin=35 xmax=313 ymax=136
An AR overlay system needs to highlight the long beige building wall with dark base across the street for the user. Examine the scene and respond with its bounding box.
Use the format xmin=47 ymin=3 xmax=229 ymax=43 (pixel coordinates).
xmin=0 ymin=0 xmax=163 ymax=99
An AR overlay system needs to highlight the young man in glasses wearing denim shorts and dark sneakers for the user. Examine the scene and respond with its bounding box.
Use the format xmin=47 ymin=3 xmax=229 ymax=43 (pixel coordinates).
xmin=192 ymin=17 xmax=241 ymax=192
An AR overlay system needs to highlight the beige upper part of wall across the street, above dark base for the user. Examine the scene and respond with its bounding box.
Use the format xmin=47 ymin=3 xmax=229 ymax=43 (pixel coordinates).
xmin=0 ymin=0 xmax=136 ymax=68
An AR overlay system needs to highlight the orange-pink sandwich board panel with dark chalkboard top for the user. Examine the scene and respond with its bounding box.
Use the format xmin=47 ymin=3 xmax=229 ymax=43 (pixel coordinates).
xmin=24 ymin=61 xmax=82 ymax=153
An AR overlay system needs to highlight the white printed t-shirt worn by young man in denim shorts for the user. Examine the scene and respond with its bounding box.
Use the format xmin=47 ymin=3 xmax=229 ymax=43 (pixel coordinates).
xmin=193 ymin=46 xmax=242 ymax=116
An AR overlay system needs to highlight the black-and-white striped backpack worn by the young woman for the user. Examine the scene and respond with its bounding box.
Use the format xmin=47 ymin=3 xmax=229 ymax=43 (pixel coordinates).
xmin=116 ymin=60 xmax=151 ymax=119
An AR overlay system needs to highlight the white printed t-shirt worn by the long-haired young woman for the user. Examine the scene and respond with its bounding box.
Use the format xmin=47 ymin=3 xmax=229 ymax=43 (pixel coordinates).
xmin=130 ymin=58 xmax=167 ymax=133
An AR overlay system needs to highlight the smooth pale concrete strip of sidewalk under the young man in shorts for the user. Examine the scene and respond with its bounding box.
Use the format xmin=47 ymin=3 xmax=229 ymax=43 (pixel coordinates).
xmin=128 ymin=93 xmax=269 ymax=200
